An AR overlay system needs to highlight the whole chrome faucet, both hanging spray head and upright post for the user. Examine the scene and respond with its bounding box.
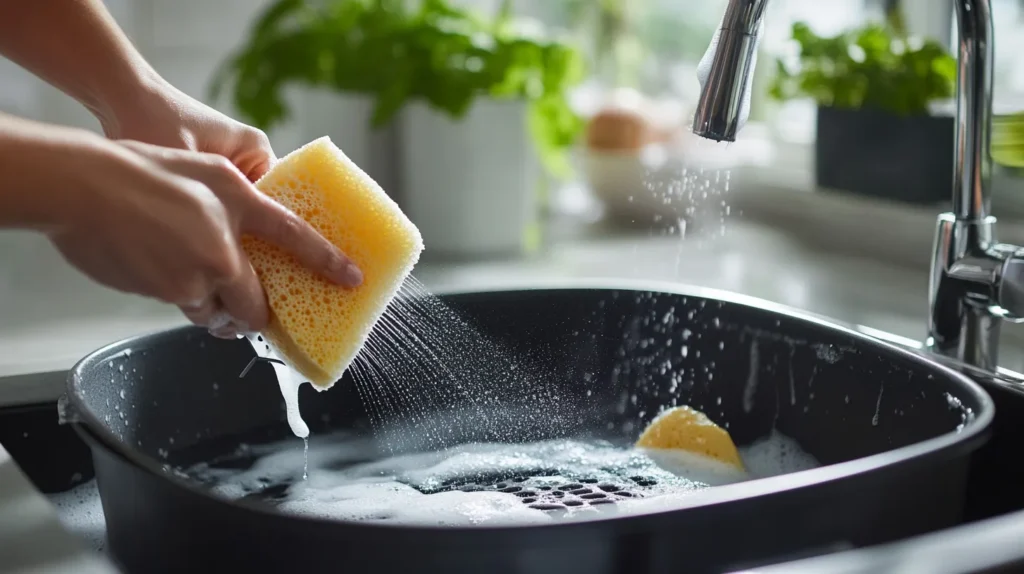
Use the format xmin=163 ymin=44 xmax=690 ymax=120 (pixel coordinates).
xmin=693 ymin=0 xmax=1024 ymax=371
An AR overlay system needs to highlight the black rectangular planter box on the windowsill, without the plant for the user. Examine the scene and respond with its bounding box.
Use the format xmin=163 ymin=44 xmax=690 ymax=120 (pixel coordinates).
xmin=815 ymin=107 xmax=954 ymax=204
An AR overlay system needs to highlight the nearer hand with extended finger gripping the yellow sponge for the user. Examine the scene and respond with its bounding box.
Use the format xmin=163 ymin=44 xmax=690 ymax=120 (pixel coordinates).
xmin=50 ymin=136 xmax=361 ymax=338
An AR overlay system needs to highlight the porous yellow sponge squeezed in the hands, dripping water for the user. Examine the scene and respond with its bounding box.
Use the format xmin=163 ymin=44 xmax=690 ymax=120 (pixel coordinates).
xmin=243 ymin=137 xmax=423 ymax=390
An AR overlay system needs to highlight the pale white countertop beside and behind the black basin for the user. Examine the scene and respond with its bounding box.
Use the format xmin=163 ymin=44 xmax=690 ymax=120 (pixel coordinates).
xmin=0 ymin=222 xmax=927 ymax=377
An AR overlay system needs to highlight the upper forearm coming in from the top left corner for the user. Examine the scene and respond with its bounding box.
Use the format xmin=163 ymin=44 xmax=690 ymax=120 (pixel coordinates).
xmin=0 ymin=0 xmax=162 ymax=128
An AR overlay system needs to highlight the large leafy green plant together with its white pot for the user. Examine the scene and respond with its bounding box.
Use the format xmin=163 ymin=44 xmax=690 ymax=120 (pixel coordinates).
xmin=213 ymin=0 xmax=585 ymax=257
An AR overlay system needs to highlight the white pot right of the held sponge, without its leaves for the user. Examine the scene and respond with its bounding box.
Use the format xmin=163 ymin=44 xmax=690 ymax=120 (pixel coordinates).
xmin=399 ymin=100 xmax=540 ymax=258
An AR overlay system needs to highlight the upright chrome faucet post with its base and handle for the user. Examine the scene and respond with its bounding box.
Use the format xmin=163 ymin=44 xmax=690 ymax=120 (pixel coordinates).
xmin=927 ymin=0 xmax=999 ymax=370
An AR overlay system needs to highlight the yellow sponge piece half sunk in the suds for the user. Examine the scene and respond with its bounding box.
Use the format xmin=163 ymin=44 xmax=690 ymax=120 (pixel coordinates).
xmin=636 ymin=406 xmax=743 ymax=469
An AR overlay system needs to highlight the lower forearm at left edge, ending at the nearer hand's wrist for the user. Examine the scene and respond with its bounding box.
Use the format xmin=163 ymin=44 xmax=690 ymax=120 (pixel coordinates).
xmin=0 ymin=114 xmax=117 ymax=231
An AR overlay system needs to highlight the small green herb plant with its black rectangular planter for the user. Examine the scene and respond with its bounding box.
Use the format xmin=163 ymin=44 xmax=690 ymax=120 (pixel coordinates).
xmin=770 ymin=5 xmax=956 ymax=204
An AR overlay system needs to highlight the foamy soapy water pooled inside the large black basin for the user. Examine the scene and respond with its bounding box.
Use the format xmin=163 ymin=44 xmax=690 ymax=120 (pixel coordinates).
xmin=176 ymin=432 xmax=818 ymax=527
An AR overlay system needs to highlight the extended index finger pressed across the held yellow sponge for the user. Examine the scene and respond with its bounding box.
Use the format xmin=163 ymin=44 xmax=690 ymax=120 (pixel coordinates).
xmin=242 ymin=193 xmax=362 ymax=286
